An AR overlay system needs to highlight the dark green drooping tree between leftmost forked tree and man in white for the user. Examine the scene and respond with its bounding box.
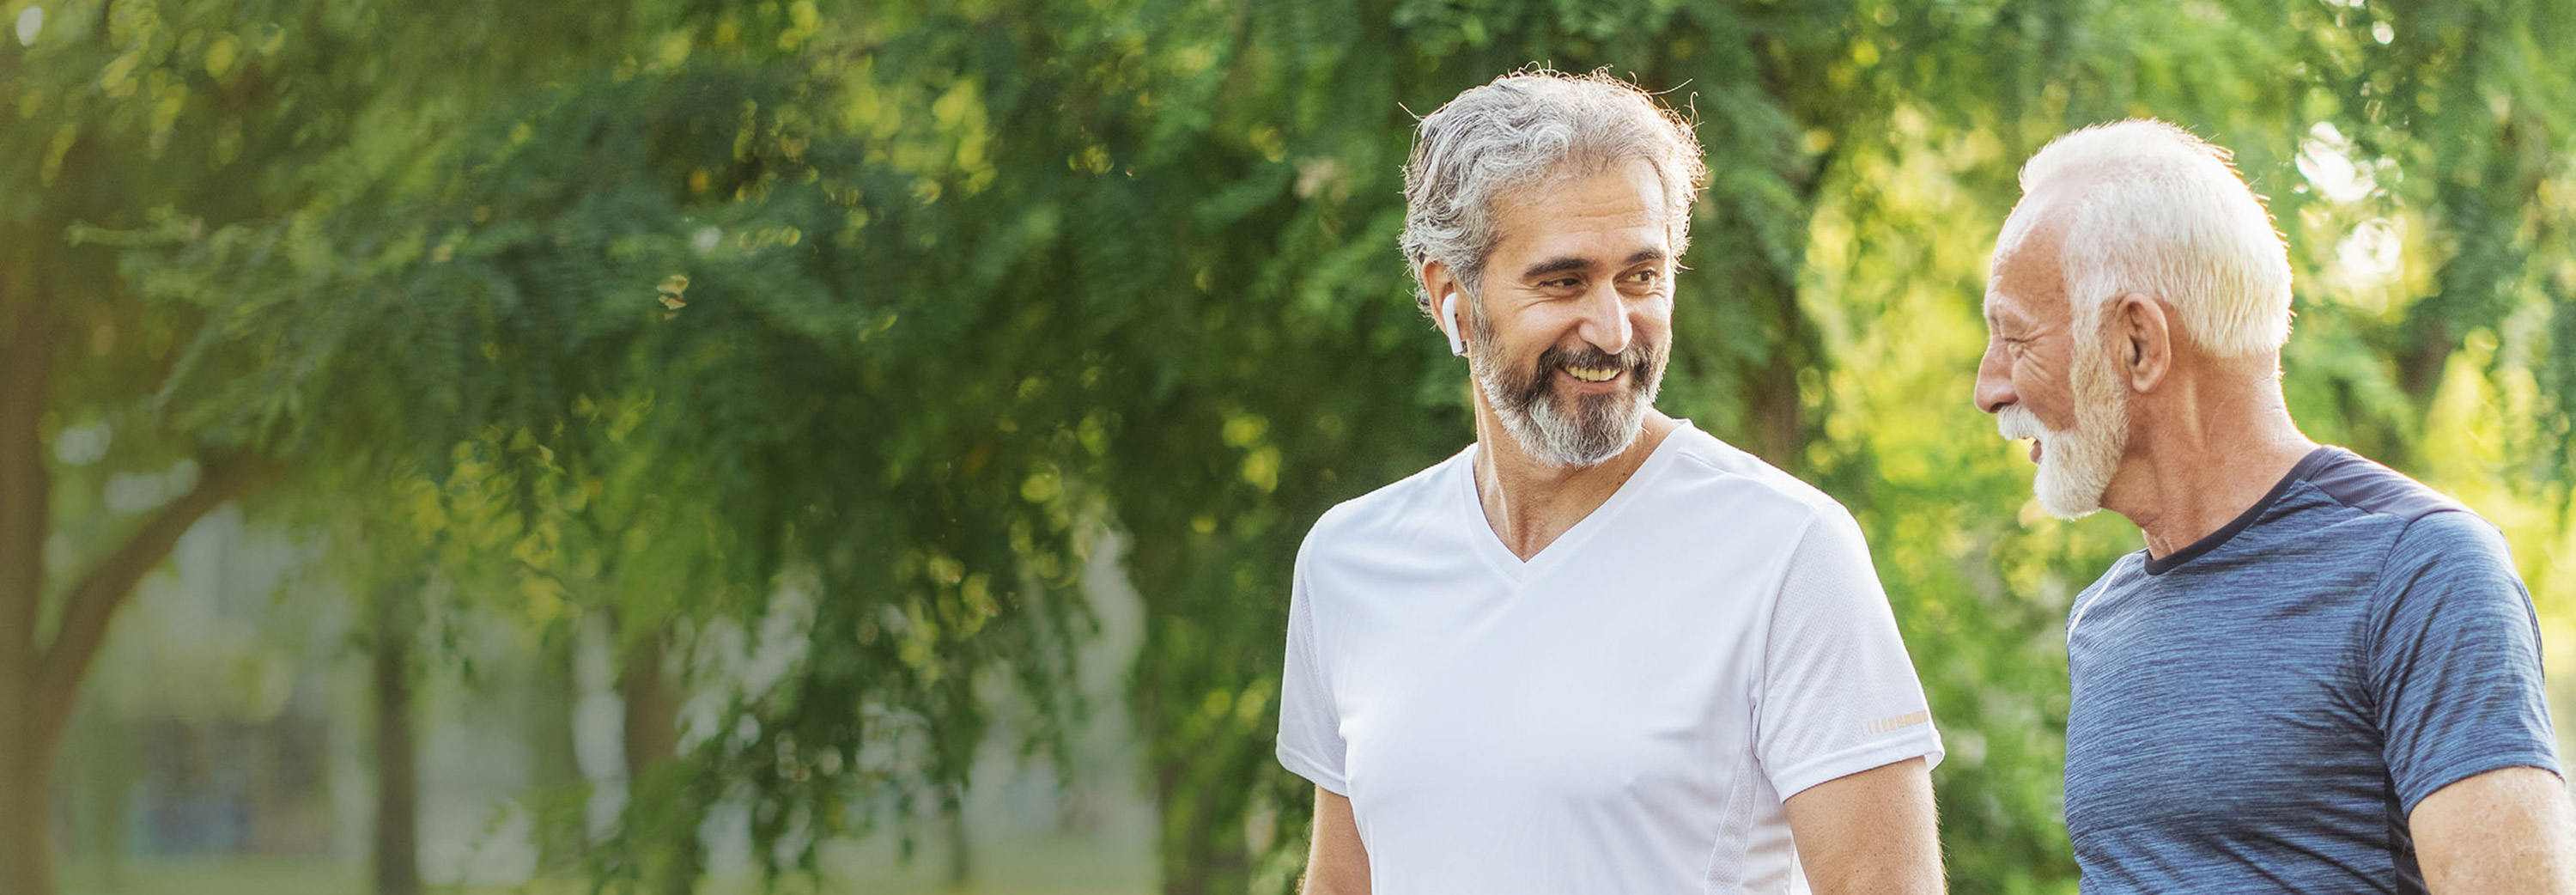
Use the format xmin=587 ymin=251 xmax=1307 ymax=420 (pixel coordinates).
xmin=129 ymin=10 xmax=1108 ymax=890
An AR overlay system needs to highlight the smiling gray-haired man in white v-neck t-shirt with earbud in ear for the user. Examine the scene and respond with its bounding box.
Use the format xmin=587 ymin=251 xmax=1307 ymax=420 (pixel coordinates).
xmin=1278 ymin=72 xmax=1942 ymax=895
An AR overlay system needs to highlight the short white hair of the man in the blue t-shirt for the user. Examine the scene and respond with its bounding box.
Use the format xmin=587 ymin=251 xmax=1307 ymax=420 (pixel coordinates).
xmin=2004 ymin=119 xmax=2290 ymax=358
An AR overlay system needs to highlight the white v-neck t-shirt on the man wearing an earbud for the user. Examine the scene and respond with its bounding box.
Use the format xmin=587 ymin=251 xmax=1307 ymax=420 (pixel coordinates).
xmin=1278 ymin=420 xmax=1942 ymax=895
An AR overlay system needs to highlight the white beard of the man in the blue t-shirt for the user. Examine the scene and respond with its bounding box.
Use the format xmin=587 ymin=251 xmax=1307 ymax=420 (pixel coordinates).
xmin=1994 ymin=338 xmax=2128 ymax=519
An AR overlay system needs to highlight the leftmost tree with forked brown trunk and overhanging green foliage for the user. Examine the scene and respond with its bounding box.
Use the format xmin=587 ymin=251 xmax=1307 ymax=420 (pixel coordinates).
xmin=0 ymin=0 xmax=752 ymax=892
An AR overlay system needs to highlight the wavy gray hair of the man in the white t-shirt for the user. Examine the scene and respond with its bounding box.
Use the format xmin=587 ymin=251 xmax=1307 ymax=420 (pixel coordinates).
xmin=1399 ymin=67 xmax=1708 ymax=320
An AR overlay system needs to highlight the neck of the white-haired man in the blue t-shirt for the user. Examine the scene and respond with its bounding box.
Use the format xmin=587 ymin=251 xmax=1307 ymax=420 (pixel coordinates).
xmin=2102 ymin=376 xmax=2316 ymax=557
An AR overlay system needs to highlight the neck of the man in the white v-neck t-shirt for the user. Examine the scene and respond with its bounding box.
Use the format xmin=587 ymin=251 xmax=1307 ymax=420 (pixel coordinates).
xmin=1476 ymin=394 xmax=1682 ymax=560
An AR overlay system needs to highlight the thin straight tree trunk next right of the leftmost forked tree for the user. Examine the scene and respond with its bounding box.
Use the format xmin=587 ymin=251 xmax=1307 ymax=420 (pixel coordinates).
xmin=376 ymin=586 xmax=420 ymax=895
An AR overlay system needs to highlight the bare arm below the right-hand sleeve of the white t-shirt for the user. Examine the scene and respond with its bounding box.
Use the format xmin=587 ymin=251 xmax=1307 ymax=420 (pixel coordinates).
xmin=1783 ymin=758 xmax=1942 ymax=895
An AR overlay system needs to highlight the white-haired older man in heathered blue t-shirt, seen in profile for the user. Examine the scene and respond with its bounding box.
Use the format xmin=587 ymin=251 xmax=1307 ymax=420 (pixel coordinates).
xmin=1976 ymin=121 xmax=2576 ymax=895
